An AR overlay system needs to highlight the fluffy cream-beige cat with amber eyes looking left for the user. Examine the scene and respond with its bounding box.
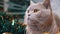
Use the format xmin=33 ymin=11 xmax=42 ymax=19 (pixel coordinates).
xmin=24 ymin=0 xmax=60 ymax=34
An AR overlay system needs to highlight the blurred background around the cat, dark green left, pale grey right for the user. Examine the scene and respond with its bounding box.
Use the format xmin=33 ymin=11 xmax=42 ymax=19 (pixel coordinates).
xmin=0 ymin=0 xmax=60 ymax=34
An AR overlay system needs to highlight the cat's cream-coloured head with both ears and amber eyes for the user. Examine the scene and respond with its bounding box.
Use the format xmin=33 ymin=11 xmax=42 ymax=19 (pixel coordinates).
xmin=26 ymin=1 xmax=51 ymax=23
